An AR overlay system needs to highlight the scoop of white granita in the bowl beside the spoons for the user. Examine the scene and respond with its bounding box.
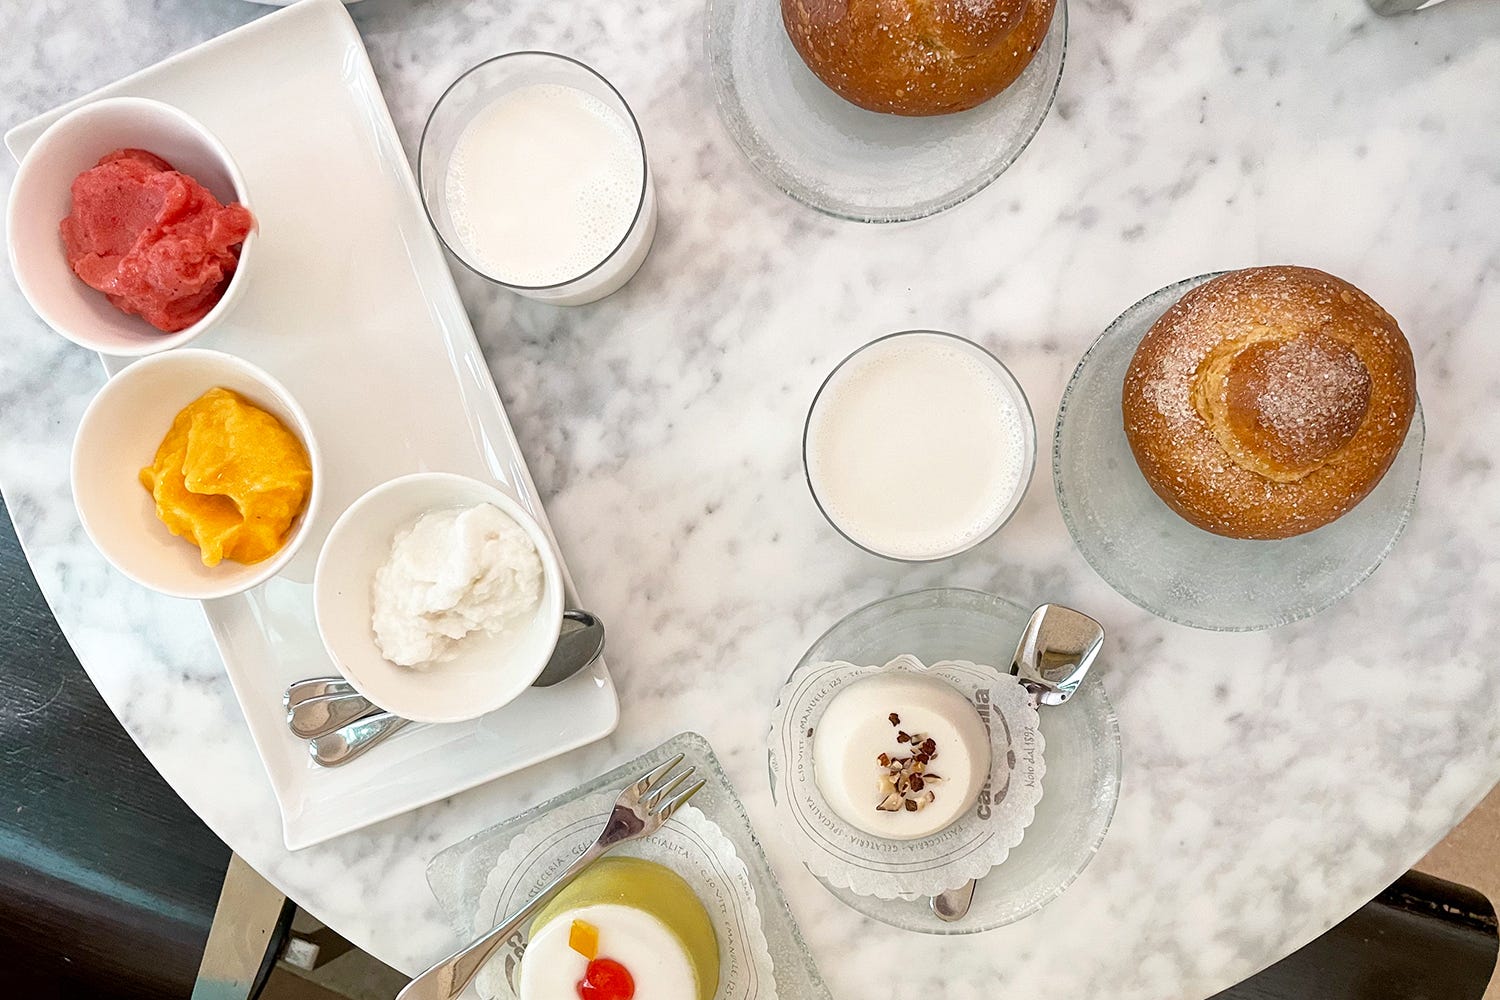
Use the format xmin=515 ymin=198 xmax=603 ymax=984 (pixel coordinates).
xmin=371 ymin=504 xmax=543 ymax=667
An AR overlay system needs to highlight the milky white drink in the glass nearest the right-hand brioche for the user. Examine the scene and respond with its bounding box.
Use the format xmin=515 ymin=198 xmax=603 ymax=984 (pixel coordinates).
xmin=806 ymin=333 xmax=1035 ymax=559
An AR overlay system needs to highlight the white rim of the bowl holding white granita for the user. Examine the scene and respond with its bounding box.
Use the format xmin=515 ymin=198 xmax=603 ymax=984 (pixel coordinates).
xmin=312 ymin=471 xmax=567 ymax=724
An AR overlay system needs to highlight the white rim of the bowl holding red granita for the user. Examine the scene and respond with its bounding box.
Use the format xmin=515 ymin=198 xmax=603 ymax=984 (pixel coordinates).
xmin=6 ymin=97 xmax=260 ymax=357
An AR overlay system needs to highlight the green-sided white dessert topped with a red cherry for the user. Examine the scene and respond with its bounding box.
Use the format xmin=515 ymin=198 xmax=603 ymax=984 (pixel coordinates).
xmin=519 ymin=858 xmax=719 ymax=1000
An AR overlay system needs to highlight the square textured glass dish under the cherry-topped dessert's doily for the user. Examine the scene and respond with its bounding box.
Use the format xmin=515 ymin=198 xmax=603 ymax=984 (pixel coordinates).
xmin=428 ymin=733 xmax=833 ymax=1000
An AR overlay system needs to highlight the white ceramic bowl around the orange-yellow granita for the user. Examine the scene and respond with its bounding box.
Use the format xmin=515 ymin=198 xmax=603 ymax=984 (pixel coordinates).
xmin=72 ymin=348 xmax=323 ymax=601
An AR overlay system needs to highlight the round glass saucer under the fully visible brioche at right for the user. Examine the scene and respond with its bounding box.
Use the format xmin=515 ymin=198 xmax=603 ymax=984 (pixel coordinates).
xmin=1052 ymin=274 xmax=1424 ymax=631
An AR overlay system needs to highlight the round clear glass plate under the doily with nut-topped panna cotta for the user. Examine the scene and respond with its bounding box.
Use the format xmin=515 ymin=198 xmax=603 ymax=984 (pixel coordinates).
xmin=771 ymin=589 xmax=1121 ymax=934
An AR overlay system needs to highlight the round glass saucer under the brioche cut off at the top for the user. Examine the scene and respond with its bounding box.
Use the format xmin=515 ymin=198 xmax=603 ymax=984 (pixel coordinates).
xmin=708 ymin=0 xmax=1068 ymax=222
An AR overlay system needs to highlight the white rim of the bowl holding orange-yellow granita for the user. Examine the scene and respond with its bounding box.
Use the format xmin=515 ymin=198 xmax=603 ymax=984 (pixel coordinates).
xmin=68 ymin=348 xmax=323 ymax=601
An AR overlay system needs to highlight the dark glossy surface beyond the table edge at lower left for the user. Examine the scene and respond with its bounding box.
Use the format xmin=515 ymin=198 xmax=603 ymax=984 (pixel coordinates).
xmin=0 ymin=502 xmax=230 ymax=1000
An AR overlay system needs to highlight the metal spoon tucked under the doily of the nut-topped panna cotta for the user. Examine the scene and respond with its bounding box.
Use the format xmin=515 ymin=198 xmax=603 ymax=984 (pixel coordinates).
xmin=929 ymin=604 xmax=1104 ymax=924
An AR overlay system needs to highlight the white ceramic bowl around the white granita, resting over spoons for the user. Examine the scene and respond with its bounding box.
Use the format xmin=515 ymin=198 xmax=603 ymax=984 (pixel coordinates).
xmin=312 ymin=472 xmax=563 ymax=723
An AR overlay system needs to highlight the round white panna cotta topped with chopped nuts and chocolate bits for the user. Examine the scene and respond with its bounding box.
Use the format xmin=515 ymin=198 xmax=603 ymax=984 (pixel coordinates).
xmin=813 ymin=672 xmax=990 ymax=840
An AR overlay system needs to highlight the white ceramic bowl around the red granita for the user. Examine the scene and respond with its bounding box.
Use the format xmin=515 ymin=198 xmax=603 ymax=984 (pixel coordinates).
xmin=6 ymin=97 xmax=255 ymax=357
